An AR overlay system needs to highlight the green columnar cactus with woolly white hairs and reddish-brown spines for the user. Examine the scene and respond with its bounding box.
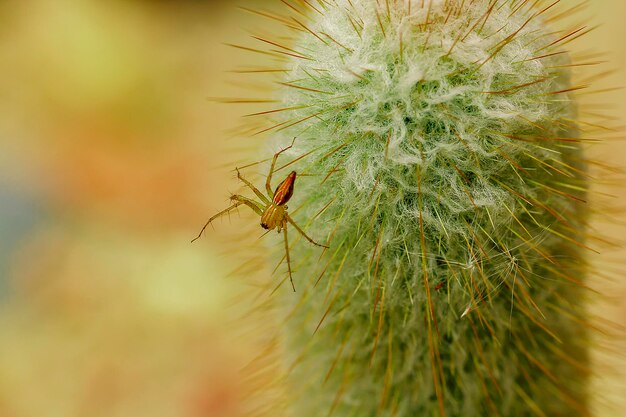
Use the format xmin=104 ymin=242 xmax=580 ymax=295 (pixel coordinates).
xmin=227 ymin=0 xmax=612 ymax=417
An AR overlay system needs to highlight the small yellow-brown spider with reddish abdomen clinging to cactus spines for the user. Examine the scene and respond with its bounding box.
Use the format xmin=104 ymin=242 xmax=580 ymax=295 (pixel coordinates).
xmin=191 ymin=139 xmax=328 ymax=292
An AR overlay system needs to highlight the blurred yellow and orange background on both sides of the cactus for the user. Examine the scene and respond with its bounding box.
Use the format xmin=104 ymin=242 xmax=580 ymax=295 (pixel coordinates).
xmin=0 ymin=0 xmax=626 ymax=417
